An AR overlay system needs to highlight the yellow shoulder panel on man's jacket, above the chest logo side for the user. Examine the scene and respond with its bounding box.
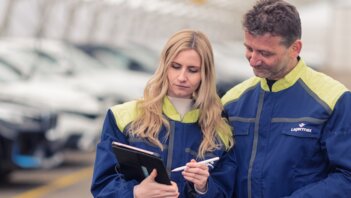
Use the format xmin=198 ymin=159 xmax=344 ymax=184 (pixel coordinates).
xmin=301 ymin=67 xmax=348 ymax=110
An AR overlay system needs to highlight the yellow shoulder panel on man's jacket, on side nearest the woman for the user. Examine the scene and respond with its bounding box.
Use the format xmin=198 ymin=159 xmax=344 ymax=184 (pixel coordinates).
xmin=222 ymin=77 xmax=260 ymax=105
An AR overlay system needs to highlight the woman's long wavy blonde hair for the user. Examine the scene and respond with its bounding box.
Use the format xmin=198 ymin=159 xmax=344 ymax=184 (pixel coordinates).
xmin=129 ymin=30 xmax=234 ymax=158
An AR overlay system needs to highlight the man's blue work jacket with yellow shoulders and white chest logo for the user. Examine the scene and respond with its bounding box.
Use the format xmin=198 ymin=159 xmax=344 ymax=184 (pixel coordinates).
xmin=222 ymin=59 xmax=351 ymax=198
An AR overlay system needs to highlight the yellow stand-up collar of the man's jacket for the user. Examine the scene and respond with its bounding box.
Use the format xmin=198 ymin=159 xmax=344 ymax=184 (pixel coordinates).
xmin=261 ymin=59 xmax=307 ymax=92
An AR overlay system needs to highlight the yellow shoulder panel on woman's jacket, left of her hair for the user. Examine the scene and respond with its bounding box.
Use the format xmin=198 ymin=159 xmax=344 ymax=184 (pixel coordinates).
xmin=111 ymin=101 xmax=137 ymax=132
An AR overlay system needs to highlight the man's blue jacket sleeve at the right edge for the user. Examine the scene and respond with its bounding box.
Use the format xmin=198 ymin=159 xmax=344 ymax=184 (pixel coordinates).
xmin=291 ymin=92 xmax=351 ymax=197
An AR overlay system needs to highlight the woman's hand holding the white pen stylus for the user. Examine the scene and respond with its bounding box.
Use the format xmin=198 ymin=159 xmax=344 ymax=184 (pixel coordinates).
xmin=182 ymin=159 xmax=210 ymax=192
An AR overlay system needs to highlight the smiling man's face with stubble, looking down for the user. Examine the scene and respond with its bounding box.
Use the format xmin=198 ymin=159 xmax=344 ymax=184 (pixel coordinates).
xmin=244 ymin=32 xmax=301 ymax=80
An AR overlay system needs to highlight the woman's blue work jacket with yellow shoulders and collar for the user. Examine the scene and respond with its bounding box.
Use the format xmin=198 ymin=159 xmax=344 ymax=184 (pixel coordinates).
xmin=91 ymin=97 xmax=236 ymax=198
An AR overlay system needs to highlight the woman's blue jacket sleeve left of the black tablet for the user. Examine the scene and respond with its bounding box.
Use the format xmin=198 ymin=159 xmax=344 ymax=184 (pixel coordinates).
xmin=91 ymin=110 xmax=137 ymax=198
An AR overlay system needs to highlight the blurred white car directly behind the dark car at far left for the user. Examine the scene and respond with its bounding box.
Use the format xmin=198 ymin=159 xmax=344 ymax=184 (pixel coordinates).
xmin=0 ymin=52 xmax=103 ymax=150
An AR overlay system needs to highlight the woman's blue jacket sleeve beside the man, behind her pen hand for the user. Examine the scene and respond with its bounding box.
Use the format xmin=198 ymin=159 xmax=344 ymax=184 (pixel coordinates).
xmin=191 ymin=148 xmax=237 ymax=198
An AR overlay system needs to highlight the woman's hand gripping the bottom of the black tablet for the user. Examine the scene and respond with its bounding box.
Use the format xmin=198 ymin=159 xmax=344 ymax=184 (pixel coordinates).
xmin=134 ymin=169 xmax=179 ymax=198
